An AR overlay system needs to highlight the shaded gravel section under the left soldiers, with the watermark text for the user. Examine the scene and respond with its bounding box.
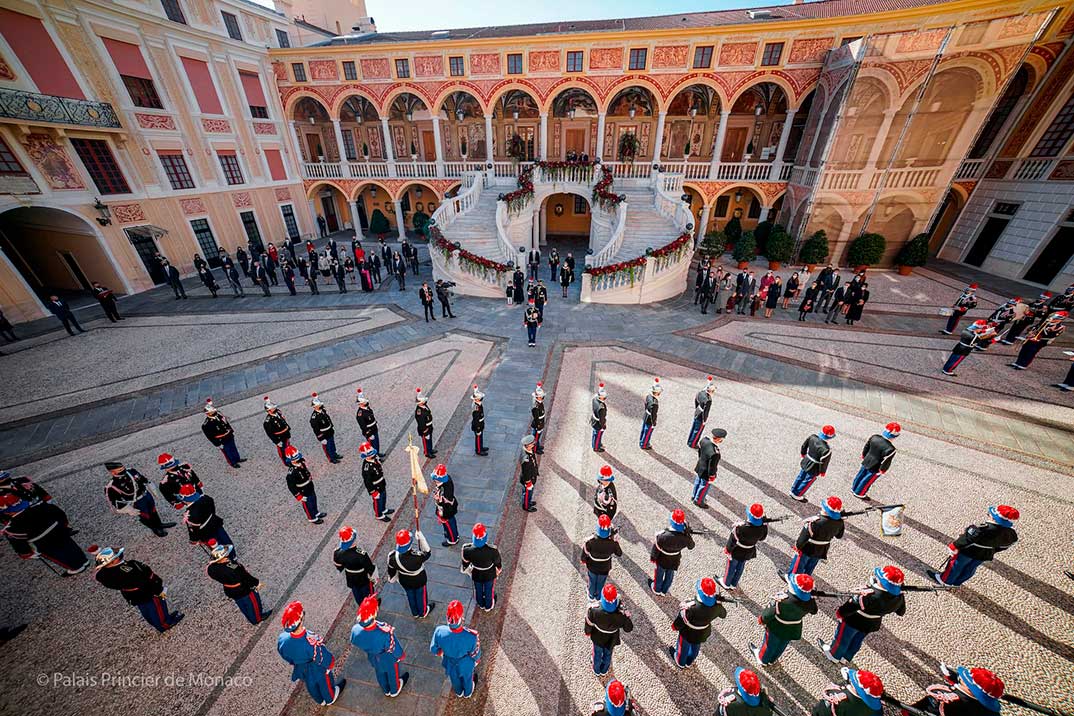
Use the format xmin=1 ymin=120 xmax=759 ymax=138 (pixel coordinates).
xmin=0 ymin=337 xmax=491 ymax=716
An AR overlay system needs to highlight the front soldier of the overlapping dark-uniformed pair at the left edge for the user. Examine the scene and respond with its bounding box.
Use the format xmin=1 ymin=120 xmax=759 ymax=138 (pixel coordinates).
xmin=0 ymin=492 xmax=89 ymax=576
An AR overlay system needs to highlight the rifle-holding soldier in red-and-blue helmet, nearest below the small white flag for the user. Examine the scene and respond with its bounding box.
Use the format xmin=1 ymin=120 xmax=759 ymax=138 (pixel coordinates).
xmin=821 ymin=565 xmax=906 ymax=663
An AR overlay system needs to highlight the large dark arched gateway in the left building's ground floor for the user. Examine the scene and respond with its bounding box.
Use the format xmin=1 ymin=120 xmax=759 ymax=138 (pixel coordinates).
xmin=0 ymin=206 xmax=127 ymax=309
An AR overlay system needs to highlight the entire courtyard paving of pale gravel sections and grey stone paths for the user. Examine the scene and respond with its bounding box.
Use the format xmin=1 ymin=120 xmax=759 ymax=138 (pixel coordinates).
xmin=0 ymin=253 xmax=1074 ymax=716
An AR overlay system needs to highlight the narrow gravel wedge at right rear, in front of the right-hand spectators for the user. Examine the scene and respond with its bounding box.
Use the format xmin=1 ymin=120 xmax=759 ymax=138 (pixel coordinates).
xmin=700 ymin=320 xmax=1074 ymax=425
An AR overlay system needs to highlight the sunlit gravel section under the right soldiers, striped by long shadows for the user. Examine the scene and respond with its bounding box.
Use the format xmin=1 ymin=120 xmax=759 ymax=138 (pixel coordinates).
xmin=484 ymin=348 xmax=1074 ymax=716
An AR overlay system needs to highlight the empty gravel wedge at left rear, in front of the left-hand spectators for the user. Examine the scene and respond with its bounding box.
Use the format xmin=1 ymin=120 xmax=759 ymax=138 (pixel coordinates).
xmin=0 ymin=308 xmax=402 ymax=422
